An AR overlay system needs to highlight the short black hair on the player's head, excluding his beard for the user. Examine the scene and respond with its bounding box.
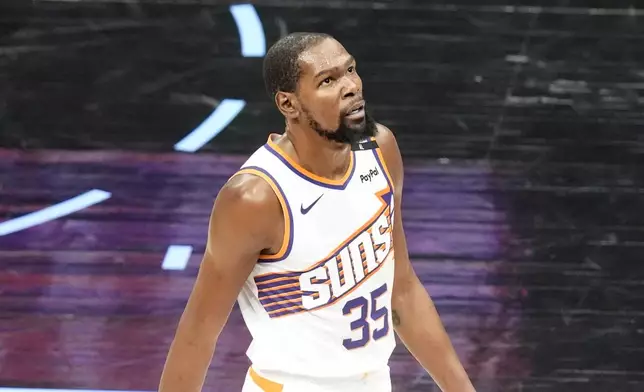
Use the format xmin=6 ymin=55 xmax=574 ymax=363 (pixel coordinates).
xmin=264 ymin=32 xmax=333 ymax=99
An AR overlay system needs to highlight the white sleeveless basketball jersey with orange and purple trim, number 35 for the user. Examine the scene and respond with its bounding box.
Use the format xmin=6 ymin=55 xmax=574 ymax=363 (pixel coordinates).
xmin=238 ymin=135 xmax=396 ymax=377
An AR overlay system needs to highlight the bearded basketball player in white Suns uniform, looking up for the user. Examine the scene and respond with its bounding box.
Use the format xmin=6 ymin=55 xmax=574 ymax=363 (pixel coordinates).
xmin=159 ymin=33 xmax=474 ymax=392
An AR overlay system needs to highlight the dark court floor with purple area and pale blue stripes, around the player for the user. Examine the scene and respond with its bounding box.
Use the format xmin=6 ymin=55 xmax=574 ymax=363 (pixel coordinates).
xmin=0 ymin=0 xmax=644 ymax=392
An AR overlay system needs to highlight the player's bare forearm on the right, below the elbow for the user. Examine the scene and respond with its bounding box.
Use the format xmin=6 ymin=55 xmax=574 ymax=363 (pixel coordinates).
xmin=392 ymin=281 xmax=474 ymax=392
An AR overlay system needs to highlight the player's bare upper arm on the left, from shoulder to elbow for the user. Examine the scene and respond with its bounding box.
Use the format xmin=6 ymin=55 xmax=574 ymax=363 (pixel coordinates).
xmin=184 ymin=174 xmax=282 ymax=339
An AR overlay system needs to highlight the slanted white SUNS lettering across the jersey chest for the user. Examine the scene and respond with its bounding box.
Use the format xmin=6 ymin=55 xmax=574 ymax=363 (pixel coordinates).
xmin=300 ymin=213 xmax=391 ymax=310
